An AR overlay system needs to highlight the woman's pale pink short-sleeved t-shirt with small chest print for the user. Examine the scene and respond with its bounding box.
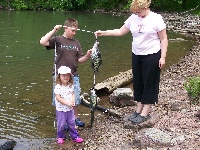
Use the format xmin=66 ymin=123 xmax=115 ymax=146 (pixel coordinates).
xmin=125 ymin=12 xmax=166 ymax=55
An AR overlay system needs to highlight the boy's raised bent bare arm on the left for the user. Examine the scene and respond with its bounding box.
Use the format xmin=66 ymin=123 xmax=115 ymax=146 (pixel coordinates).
xmin=40 ymin=25 xmax=62 ymax=46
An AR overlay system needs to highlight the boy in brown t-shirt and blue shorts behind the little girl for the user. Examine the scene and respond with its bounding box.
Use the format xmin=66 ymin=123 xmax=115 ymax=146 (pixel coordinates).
xmin=40 ymin=18 xmax=91 ymax=127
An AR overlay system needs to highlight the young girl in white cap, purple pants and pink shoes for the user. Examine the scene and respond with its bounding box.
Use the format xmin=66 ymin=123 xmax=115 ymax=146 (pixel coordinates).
xmin=54 ymin=66 xmax=83 ymax=144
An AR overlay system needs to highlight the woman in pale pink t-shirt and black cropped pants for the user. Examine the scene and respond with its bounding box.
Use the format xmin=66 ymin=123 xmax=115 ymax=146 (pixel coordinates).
xmin=95 ymin=0 xmax=168 ymax=124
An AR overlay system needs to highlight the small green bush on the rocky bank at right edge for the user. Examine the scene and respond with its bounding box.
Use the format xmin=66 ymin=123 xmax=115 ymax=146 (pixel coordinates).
xmin=184 ymin=76 xmax=200 ymax=103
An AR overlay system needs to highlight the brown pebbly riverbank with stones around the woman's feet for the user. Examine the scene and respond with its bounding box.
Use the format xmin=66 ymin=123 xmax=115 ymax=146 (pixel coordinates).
xmin=76 ymin=14 xmax=200 ymax=150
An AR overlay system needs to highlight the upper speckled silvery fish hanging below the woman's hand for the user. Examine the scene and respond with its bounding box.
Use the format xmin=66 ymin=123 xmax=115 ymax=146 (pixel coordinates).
xmin=91 ymin=39 xmax=102 ymax=73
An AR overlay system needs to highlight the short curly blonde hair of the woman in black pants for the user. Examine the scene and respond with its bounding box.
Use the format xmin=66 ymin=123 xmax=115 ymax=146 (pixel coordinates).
xmin=130 ymin=0 xmax=151 ymax=12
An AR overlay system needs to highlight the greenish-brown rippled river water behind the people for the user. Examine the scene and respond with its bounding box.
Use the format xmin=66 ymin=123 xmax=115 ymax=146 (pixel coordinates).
xmin=0 ymin=11 xmax=194 ymax=150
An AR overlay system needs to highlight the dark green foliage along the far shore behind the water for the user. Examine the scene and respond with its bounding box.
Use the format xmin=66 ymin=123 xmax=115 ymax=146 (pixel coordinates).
xmin=0 ymin=0 xmax=200 ymax=14
